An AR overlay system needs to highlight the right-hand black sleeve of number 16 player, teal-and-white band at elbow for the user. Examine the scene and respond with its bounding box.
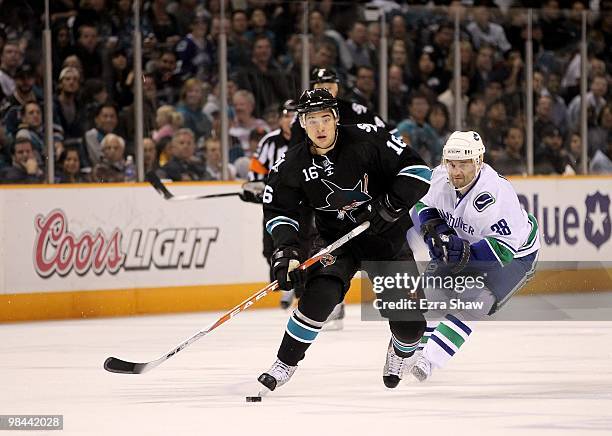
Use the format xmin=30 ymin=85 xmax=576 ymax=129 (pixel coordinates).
xmin=366 ymin=125 xmax=431 ymax=210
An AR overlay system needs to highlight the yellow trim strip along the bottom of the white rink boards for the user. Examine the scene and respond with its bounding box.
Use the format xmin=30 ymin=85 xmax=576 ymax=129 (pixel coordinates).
xmin=0 ymin=269 xmax=612 ymax=323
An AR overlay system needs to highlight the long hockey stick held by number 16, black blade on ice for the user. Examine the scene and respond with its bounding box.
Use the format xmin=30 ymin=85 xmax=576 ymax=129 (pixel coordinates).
xmin=104 ymin=221 xmax=370 ymax=374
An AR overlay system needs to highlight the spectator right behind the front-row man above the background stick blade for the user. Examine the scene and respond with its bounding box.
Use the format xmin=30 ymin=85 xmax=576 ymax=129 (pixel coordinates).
xmin=176 ymin=79 xmax=212 ymax=141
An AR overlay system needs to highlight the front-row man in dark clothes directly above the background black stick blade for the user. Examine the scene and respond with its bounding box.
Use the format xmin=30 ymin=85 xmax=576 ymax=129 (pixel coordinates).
xmin=159 ymin=129 xmax=210 ymax=181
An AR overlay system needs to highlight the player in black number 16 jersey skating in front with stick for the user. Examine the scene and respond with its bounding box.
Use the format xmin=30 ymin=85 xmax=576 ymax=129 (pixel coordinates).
xmin=258 ymin=89 xmax=431 ymax=390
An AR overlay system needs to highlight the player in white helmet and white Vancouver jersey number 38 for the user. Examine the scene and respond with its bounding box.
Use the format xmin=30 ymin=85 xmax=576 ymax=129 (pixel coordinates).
xmin=411 ymin=131 xmax=540 ymax=381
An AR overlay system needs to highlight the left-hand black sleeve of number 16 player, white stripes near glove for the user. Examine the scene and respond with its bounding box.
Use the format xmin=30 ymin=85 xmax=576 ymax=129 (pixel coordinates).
xmin=263 ymin=156 xmax=303 ymax=249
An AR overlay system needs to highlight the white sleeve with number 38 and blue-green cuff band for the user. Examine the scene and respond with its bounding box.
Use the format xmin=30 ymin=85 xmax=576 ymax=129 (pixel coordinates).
xmin=470 ymin=178 xmax=532 ymax=266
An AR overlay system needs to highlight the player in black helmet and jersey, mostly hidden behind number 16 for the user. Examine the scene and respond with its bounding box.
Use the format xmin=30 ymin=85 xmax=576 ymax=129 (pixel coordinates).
xmin=291 ymin=68 xmax=387 ymax=144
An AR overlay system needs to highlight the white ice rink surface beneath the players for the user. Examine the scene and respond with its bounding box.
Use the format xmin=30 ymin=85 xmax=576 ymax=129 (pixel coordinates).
xmin=0 ymin=297 xmax=612 ymax=436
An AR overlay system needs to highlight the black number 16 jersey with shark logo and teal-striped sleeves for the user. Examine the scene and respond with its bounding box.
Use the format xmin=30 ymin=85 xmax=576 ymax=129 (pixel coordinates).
xmin=263 ymin=124 xmax=431 ymax=254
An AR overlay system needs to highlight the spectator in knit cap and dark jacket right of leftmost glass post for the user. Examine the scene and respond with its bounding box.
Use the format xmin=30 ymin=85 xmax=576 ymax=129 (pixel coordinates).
xmin=53 ymin=67 xmax=85 ymax=141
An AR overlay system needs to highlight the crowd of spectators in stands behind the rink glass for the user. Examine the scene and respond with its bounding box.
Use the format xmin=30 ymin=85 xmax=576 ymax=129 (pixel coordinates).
xmin=0 ymin=0 xmax=612 ymax=183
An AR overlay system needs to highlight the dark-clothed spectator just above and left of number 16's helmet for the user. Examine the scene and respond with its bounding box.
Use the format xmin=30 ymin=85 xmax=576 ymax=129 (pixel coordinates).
xmin=237 ymin=35 xmax=289 ymax=117
